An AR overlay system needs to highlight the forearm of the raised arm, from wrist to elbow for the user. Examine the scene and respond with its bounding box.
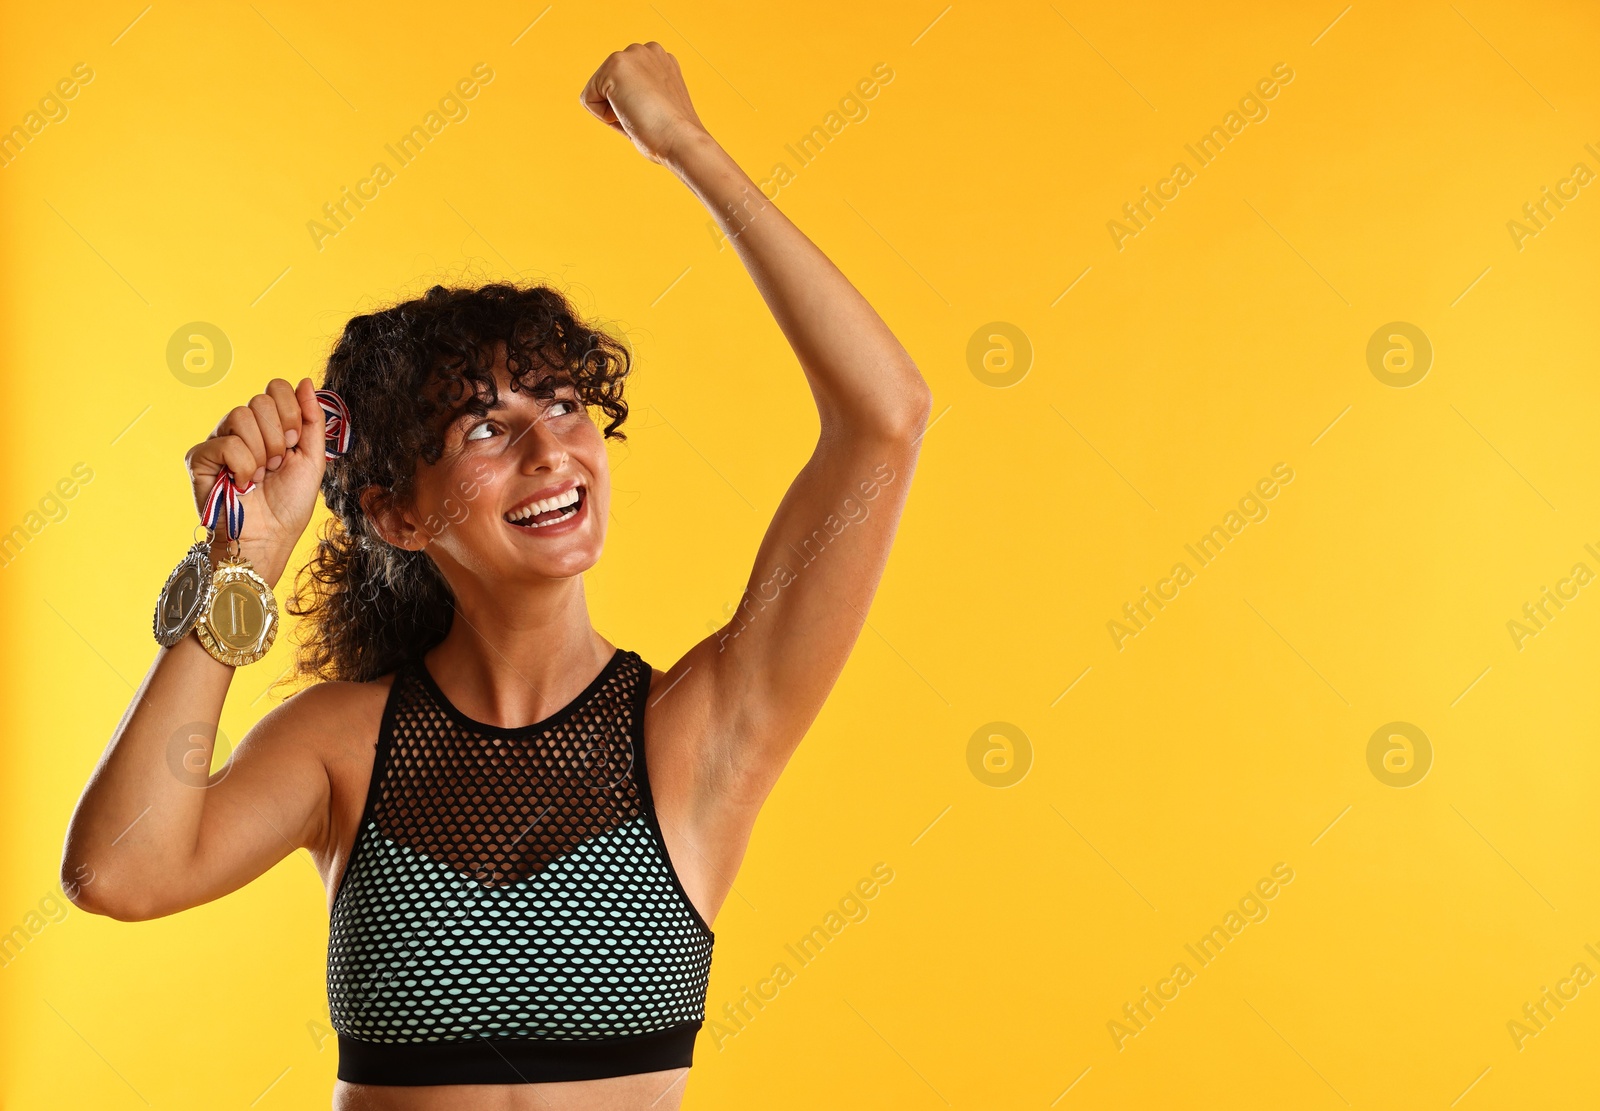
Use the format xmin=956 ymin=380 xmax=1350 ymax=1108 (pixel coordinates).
xmin=669 ymin=131 xmax=928 ymax=437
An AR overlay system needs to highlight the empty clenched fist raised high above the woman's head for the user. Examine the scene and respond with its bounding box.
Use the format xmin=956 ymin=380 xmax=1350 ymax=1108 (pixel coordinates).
xmin=579 ymin=42 xmax=706 ymax=168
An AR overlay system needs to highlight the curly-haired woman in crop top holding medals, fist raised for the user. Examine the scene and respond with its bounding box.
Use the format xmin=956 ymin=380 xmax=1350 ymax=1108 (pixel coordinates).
xmin=62 ymin=43 xmax=928 ymax=1111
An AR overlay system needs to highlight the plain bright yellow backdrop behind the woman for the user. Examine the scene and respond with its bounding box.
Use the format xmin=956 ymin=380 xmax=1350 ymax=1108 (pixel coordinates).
xmin=0 ymin=0 xmax=1600 ymax=1111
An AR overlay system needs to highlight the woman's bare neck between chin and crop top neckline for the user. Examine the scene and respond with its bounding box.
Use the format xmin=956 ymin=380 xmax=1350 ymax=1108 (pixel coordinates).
xmin=426 ymin=576 xmax=614 ymax=728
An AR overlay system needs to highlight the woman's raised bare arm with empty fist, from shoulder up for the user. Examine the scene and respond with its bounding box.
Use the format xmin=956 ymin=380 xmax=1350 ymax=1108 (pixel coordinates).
xmin=582 ymin=43 xmax=931 ymax=813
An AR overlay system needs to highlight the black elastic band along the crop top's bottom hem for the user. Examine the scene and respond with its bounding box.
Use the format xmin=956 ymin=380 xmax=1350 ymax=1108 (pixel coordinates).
xmin=339 ymin=1021 xmax=701 ymax=1087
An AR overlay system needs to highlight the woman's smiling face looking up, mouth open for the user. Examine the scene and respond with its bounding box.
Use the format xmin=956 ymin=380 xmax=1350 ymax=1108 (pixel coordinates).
xmin=368 ymin=349 xmax=611 ymax=599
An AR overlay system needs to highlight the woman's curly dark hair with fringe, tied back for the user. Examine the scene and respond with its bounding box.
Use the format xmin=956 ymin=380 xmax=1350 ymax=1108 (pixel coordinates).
xmin=283 ymin=283 xmax=632 ymax=682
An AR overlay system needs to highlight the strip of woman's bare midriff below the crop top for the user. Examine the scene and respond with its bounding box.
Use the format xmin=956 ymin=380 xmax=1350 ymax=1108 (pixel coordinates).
xmin=333 ymin=1069 xmax=688 ymax=1111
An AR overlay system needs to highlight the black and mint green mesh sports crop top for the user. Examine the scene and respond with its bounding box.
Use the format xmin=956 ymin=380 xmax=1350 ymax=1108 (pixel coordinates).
xmin=328 ymin=648 xmax=714 ymax=1085
